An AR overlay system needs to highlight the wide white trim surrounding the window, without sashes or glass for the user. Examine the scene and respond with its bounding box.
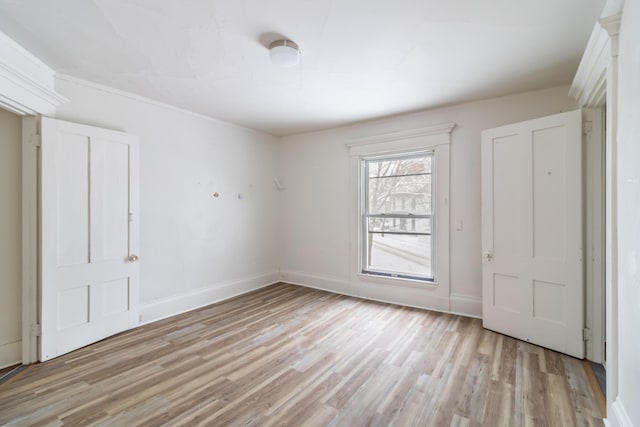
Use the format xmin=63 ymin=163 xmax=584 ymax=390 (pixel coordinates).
xmin=346 ymin=123 xmax=455 ymax=311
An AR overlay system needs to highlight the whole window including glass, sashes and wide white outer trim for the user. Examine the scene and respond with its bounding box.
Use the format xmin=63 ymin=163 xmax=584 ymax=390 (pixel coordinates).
xmin=348 ymin=123 xmax=457 ymax=292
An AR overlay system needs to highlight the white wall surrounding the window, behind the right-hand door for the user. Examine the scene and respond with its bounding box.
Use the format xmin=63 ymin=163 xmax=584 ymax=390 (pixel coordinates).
xmin=282 ymin=86 xmax=575 ymax=316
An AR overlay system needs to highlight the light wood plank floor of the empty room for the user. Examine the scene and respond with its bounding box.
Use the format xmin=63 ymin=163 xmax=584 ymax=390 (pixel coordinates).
xmin=0 ymin=284 xmax=602 ymax=427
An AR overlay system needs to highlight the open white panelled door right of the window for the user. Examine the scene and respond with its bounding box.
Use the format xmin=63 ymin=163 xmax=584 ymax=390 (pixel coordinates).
xmin=482 ymin=111 xmax=584 ymax=358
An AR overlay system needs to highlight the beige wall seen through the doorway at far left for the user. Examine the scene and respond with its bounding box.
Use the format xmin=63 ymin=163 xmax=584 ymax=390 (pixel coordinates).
xmin=0 ymin=108 xmax=22 ymax=368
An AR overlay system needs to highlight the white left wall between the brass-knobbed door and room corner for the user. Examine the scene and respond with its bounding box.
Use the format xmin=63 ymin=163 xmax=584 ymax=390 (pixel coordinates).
xmin=56 ymin=77 xmax=281 ymax=322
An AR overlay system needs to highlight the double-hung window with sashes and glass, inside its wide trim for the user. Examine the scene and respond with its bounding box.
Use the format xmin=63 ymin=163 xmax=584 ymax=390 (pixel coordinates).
xmin=361 ymin=151 xmax=435 ymax=281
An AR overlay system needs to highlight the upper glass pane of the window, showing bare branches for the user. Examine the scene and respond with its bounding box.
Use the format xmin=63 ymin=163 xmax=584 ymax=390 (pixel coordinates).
xmin=367 ymin=162 xmax=432 ymax=215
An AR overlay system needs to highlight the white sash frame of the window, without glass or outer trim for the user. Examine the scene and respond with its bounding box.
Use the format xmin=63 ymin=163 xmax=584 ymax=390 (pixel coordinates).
xmin=359 ymin=152 xmax=437 ymax=283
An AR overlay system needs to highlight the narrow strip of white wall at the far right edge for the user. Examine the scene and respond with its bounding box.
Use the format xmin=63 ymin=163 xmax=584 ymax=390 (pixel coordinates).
xmin=609 ymin=0 xmax=640 ymax=426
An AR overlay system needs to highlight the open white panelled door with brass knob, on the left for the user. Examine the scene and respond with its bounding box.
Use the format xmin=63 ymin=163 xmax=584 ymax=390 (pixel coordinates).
xmin=40 ymin=117 xmax=139 ymax=361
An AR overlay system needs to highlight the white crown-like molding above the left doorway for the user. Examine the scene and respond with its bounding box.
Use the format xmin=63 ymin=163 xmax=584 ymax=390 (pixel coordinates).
xmin=0 ymin=32 xmax=69 ymax=116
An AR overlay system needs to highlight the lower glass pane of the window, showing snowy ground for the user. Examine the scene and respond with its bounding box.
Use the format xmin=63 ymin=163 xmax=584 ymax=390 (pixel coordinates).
xmin=367 ymin=233 xmax=433 ymax=278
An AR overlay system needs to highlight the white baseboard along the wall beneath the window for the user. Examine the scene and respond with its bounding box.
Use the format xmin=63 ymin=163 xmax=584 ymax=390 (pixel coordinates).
xmin=282 ymin=271 xmax=482 ymax=317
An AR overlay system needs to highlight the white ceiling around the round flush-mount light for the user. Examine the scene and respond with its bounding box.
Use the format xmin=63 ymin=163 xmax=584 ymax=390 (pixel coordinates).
xmin=0 ymin=0 xmax=604 ymax=135
